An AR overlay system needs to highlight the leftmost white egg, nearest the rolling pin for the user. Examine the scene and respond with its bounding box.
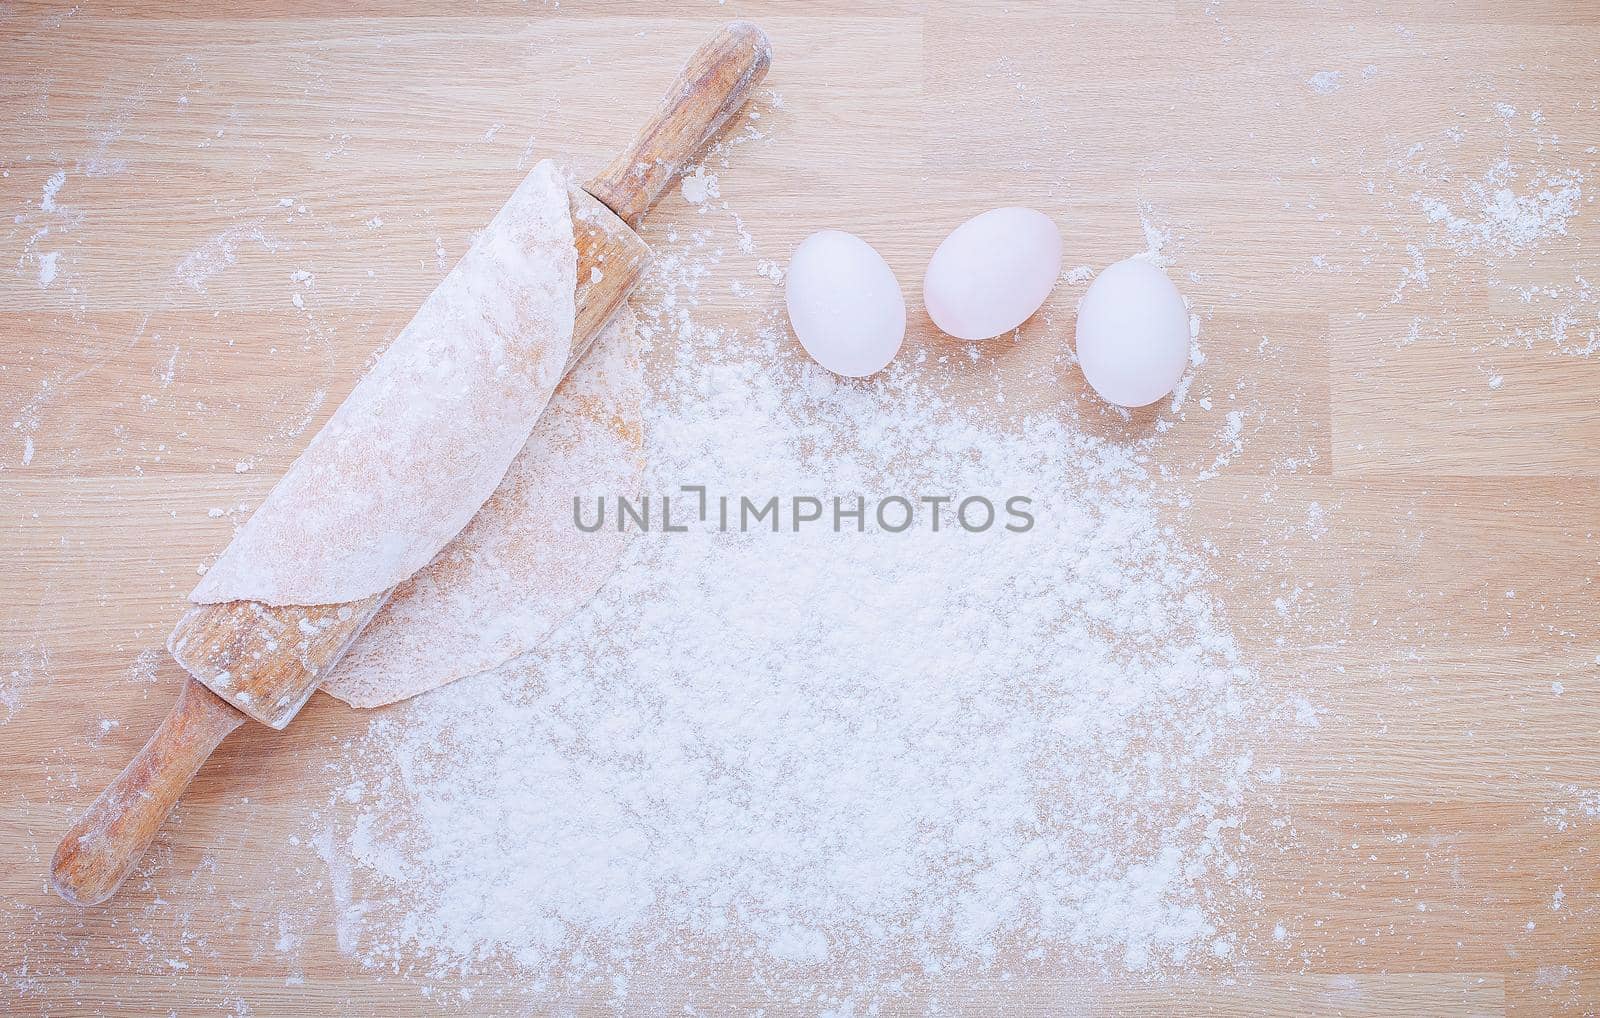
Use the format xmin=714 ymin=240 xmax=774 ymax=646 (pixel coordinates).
xmin=784 ymin=230 xmax=906 ymax=378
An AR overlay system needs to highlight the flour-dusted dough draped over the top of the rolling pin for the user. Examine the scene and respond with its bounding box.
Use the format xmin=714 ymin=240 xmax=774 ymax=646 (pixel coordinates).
xmin=190 ymin=160 xmax=578 ymax=605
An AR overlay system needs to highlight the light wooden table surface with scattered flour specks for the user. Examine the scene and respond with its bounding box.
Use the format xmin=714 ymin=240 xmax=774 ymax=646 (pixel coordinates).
xmin=0 ymin=0 xmax=1600 ymax=1015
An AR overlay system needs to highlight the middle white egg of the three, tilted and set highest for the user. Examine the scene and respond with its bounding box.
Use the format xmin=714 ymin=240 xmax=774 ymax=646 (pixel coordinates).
xmin=922 ymin=208 xmax=1061 ymax=339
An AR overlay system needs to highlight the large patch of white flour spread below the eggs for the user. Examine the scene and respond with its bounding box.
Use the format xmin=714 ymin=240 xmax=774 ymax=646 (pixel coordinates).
xmin=321 ymin=243 xmax=1266 ymax=1005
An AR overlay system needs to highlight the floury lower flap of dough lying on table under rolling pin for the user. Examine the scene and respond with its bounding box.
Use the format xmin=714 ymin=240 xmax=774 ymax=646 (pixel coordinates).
xmin=322 ymin=307 xmax=643 ymax=707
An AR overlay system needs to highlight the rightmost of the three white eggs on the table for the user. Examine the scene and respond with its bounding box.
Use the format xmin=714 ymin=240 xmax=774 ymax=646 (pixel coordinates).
xmin=1078 ymin=258 xmax=1189 ymax=407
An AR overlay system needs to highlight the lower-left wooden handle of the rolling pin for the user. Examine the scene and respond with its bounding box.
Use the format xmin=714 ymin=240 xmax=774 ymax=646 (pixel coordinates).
xmin=50 ymin=679 xmax=245 ymax=904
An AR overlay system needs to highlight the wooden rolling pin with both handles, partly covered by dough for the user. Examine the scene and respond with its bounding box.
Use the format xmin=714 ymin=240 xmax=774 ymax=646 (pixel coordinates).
xmin=50 ymin=21 xmax=771 ymax=904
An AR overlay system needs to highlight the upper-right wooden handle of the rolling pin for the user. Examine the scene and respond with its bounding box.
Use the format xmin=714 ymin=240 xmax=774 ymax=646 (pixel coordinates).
xmin=586 ymin=21 xmax=773 ymax=229
